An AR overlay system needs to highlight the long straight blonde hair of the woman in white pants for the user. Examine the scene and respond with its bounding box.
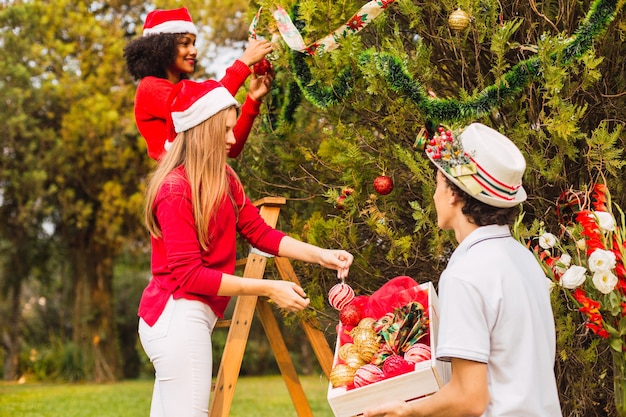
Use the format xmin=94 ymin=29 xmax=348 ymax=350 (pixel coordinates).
xmin=144 ymin=106 xmax=239 ymax=250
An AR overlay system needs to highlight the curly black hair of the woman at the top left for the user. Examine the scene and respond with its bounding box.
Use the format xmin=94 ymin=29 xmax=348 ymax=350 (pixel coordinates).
xmin=124 ymin=33 xmax=188 ymax=80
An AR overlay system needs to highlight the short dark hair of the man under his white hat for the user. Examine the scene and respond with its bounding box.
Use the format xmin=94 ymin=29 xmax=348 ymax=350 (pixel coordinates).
xmin=445 ymin=177 xmax=520 ymax=226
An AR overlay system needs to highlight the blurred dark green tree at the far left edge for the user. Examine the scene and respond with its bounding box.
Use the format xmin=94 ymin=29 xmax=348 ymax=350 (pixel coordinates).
xmin=0 ymin=0 xmax=64 ymax=380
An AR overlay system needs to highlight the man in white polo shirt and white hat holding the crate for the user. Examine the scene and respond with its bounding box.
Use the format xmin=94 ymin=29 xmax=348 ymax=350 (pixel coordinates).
xmin=364 ymin=123 xmax=562 ymax=417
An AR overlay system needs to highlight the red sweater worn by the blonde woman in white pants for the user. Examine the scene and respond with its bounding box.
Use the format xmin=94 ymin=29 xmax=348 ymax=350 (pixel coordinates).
xmin=139 ymin=166 xmax=285 ymax=326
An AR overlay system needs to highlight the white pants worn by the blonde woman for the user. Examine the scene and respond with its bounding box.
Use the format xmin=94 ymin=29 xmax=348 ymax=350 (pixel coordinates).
xmin=139 ymin=297 xmax=217 ymax=417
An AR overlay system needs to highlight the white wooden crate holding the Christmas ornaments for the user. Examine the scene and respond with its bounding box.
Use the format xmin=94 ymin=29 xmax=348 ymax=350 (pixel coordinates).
xmin=327 ymin=282 xmax=450 ymax=417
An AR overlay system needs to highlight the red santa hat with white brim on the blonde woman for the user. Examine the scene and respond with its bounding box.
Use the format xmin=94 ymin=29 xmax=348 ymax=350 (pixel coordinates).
xmin=166 ymin=80 xmax=239 ymax=138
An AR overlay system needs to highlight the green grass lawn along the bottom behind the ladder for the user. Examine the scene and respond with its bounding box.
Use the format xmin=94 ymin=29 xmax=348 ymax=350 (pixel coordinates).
xmin=0 ymin=375 xmax=333 ymax=417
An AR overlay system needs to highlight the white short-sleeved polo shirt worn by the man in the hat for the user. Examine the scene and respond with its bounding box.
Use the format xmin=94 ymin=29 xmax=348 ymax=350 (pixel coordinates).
xmin=437 ymin=225 xmax=562 ymax=417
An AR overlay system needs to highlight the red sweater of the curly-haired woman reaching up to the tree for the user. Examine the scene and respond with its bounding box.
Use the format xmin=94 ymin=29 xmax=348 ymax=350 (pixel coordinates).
xmin=135 ymin=60 xmax=261 ymax=161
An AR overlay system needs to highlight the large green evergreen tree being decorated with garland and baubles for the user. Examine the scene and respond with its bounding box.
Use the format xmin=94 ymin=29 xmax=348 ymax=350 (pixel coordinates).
xmin=227 ymin=0 xmax=626 ymax=416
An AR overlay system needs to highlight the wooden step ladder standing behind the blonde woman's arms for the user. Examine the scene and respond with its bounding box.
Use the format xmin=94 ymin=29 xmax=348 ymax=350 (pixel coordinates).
xmin=209 ymin=197 xmax=333 ymax=417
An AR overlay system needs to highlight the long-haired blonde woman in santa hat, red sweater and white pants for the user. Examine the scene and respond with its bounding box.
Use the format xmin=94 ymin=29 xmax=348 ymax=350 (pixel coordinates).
xmin=139 ymin=80 xmax=353 ymax=417
